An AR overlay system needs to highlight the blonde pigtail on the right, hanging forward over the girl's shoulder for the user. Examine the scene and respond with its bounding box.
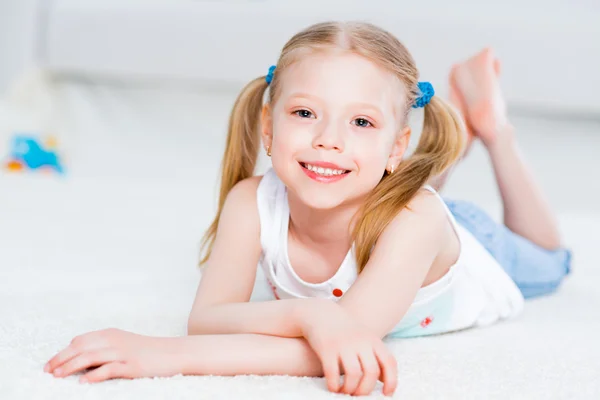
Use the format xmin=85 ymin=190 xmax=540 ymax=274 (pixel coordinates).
xmin=353 ymin=96 xmax=465 ymax=272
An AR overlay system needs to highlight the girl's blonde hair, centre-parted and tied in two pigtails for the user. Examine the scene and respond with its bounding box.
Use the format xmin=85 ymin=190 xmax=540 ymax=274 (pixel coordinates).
xmin=200 ymin=22 xmax=464 ymax=272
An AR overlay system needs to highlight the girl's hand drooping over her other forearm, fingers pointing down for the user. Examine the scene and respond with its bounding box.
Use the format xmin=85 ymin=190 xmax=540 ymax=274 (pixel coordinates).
xmin=303 ymin=303 xmax=398 ymax=396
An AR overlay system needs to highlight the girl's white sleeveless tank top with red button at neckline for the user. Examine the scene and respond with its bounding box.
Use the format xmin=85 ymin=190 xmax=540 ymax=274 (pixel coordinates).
xmin=252 ymin=169 xmax=524 ymax=337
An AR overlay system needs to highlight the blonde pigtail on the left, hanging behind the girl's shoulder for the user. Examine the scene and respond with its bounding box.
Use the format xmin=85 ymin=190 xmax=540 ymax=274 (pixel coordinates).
xmin=199 ymin=76 xmax=269 ymax=266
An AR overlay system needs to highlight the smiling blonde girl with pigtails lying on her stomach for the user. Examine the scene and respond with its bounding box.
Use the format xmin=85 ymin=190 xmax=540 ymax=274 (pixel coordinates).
xmin=45 ymin=23 xmax=569 ymax=395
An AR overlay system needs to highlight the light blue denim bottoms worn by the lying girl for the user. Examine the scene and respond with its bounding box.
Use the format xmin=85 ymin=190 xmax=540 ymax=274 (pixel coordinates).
xmin=444 ymin=199 xmax=571 ymax=298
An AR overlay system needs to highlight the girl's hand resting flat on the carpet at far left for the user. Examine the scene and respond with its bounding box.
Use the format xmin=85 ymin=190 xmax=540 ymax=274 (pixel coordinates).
xmin=44 ymin=329 xmax=181 ymax=383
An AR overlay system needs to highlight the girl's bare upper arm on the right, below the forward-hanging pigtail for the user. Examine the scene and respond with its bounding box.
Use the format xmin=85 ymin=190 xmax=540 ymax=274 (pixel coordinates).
xmin=339 ymin=191 xmax=451 ymax=337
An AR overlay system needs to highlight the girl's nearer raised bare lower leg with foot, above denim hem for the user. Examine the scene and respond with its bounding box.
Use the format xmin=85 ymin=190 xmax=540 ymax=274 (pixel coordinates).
xmin=453 ymin=49 xmax=561 ymax=250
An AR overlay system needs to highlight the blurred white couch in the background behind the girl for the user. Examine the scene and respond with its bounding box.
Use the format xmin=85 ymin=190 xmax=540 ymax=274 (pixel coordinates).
xmin=0 ymin=0 xmax=600 ymax=115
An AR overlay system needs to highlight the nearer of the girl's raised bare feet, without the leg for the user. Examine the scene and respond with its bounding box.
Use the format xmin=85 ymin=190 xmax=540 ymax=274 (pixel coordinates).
xmin=450 ymin=48 xmax=508 ymax=146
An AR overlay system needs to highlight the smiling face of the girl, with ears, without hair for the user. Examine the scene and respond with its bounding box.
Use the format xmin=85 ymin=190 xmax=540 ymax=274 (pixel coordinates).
xmin=262 ymin=53 xmax=410 ymax=209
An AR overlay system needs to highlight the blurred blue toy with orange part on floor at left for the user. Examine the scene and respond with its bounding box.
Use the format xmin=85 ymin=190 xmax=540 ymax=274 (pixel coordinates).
xmin=6 ymin=135 xmax=64 ymax=174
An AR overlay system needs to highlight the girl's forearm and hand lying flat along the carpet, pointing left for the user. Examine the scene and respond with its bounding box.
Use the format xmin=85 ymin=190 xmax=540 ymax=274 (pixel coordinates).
xmin=44 ymin=329 xmax=323 ymax=382
